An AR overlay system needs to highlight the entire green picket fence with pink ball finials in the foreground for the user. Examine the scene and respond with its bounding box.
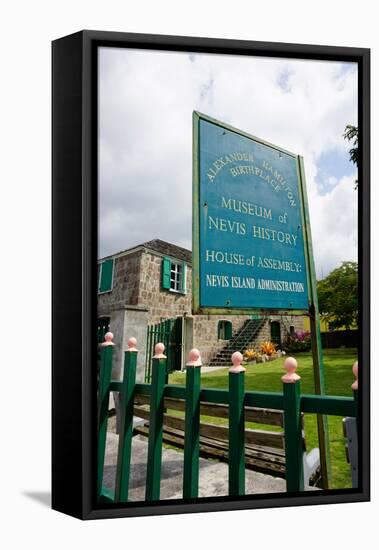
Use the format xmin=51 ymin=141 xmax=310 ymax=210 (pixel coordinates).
xmin=97 ymin=333 xmax=358 ymax=503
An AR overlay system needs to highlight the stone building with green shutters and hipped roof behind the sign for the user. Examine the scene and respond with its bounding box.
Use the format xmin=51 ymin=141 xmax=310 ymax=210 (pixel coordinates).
xmin=98 ymin=239 xmax=303 ymax=381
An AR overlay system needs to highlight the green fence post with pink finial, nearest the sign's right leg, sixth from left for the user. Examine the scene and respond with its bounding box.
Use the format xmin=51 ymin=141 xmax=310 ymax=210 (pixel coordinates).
xmin=282 ymin=357 xmax=304 ymax=492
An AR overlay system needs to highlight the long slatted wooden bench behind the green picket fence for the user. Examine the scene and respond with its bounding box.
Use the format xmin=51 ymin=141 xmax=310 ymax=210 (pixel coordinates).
xmin=134 ymin=395 xmax=320 ymax=486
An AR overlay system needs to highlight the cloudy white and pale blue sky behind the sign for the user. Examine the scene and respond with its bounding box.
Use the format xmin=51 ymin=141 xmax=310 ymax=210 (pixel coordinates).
xmin=99 ymin=48 xmax=358 ymax=278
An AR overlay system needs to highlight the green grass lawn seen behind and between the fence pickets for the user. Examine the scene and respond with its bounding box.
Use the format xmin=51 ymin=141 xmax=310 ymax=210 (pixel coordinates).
xmin=169 ymin=348 xmax=357 ymax=489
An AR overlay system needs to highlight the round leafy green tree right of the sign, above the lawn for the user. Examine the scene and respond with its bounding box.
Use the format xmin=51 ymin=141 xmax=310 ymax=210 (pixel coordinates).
xmin=317 ymin=262 xmax=358 ymax=330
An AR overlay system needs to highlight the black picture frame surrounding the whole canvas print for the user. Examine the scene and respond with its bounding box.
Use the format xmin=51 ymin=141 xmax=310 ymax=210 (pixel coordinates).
xmin=52 ymin=30 xmax=370 ymax=519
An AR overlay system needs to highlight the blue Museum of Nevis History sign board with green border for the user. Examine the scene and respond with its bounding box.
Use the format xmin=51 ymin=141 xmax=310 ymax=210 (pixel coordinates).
xmin=194 ymin=114 xmax=309 ymax=310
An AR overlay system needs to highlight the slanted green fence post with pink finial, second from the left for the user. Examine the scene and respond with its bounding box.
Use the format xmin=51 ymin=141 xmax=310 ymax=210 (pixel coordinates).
xmin=115 ymin=338 xmax=138 ymax=502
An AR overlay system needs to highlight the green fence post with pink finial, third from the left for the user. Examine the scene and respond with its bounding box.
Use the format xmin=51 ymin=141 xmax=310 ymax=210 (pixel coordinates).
xmin=146 ymin=343 xmax=167 ymax=500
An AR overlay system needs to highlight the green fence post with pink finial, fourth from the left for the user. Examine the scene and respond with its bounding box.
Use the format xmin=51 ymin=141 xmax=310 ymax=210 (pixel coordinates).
xmin=183 ymin=348 xmax=201 ymax=498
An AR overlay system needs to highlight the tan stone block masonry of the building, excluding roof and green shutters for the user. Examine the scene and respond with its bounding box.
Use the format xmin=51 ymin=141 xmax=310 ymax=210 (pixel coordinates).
xmin=98 ymin=250 xmax=303 ymax=370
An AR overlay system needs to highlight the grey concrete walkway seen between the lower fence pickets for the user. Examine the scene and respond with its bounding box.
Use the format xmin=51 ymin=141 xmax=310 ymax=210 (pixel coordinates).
xmin=104 ymin=432 xmax=292 ymax=501
